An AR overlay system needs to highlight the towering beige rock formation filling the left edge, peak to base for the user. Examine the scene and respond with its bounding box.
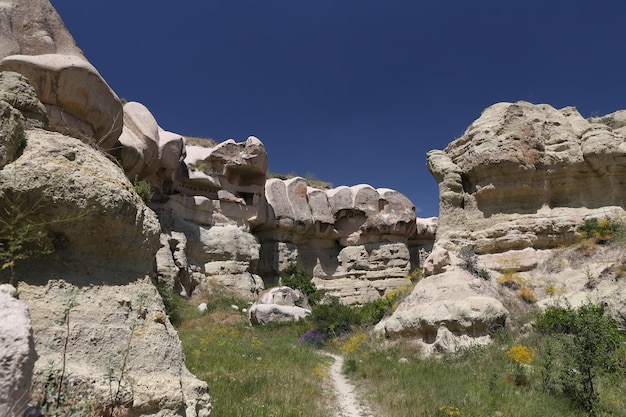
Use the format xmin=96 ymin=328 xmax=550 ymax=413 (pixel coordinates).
xmin=0 ymin=0 xmax=211 ymax=417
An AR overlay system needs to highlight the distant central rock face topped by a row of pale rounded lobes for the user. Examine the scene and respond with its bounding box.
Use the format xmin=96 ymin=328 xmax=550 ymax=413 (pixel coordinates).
xmin=254 ymin=177 xmax=436 ymax=304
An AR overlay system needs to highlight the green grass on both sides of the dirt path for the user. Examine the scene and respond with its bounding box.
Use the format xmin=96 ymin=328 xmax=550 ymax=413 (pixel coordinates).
xmin=171 ymin=290 xmax=626 ymax=417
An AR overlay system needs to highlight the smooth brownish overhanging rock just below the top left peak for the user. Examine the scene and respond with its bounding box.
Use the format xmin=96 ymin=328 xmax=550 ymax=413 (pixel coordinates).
xmin=0 ymin=54 xmax=123 ymax=151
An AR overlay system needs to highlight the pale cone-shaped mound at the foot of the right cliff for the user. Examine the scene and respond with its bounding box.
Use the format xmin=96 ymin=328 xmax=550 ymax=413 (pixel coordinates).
xmin=374 ymin=268 xmax=509 ymax=355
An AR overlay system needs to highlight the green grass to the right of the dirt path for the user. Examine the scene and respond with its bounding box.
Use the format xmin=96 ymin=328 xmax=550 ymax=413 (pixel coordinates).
xmin=350 ymin=337 xmax=626 ymax=417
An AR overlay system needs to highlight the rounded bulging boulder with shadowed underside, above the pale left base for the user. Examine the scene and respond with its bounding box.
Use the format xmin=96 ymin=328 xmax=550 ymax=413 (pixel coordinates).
xmin=0 ymin=129 xmax=160 ymax=277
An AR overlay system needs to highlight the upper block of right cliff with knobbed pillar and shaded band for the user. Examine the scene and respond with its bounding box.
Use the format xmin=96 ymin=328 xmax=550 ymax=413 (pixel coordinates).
xmin=428 ymin=102 xmax=626 ymax=253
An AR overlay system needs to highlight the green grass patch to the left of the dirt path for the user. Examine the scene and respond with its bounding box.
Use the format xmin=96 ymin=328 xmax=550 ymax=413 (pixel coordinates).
xmin=173 ymin=294 xmax=332 ymax=417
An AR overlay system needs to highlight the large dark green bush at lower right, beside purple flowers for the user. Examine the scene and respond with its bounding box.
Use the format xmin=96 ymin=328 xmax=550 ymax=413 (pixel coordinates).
xmin=534 ymin=302 xmax=623 ymax=415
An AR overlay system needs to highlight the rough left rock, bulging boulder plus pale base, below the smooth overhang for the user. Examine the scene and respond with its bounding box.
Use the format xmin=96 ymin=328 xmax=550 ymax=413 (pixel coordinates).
xmin=0 ymin=48 xmax=211 ymax=417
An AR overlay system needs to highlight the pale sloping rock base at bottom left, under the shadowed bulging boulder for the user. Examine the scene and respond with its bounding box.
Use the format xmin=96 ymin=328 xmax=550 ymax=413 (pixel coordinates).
xmin=20 ymin=278 xmax=211 ymax=417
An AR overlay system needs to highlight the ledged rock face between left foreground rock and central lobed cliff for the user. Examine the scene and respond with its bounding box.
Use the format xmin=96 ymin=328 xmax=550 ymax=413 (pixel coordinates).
xmin=151 ymin=135 xmax=267 ymax=299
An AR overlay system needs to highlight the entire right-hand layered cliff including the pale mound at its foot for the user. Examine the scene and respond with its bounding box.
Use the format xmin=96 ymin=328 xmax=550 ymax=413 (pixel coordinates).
xmin=376 ymin=102 xmax=626 ymax=354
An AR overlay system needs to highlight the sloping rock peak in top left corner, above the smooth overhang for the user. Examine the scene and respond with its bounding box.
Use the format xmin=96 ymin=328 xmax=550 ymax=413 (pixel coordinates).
xmin=0 ymin=0 xmax=83 ymax=59
